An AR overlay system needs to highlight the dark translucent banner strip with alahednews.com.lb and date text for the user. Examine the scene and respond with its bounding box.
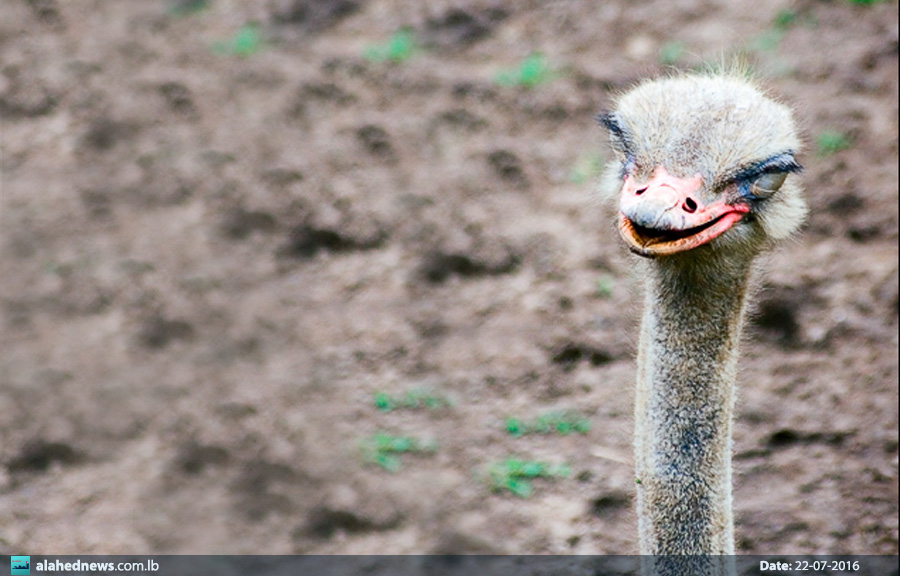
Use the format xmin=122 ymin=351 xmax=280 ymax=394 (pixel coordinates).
xmin=0 ymin=554 xmax=900 ymax=576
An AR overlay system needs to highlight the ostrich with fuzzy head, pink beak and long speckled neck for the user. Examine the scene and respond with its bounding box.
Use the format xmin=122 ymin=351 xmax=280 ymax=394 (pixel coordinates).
xmin=598 ymin=72 xmax=806 ymax=576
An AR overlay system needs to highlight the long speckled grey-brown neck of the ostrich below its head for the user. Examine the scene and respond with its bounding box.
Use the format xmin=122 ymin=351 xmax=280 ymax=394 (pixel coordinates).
xmin=635 ymin=255 xmax=750 ymax=575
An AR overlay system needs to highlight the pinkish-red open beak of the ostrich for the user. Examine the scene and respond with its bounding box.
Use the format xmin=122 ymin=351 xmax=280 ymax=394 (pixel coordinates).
xmin=618 ymin=166 xmax=750 ymax=258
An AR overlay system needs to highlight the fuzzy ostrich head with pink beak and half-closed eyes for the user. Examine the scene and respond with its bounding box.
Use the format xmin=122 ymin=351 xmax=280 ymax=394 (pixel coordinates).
xmin=598 ymin=74 xmax=806 ymax=262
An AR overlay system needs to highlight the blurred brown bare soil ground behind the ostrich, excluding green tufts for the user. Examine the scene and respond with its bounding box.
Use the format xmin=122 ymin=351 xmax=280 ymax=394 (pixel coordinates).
xmin=0 ymin=0 xmax=898 ymax=554
